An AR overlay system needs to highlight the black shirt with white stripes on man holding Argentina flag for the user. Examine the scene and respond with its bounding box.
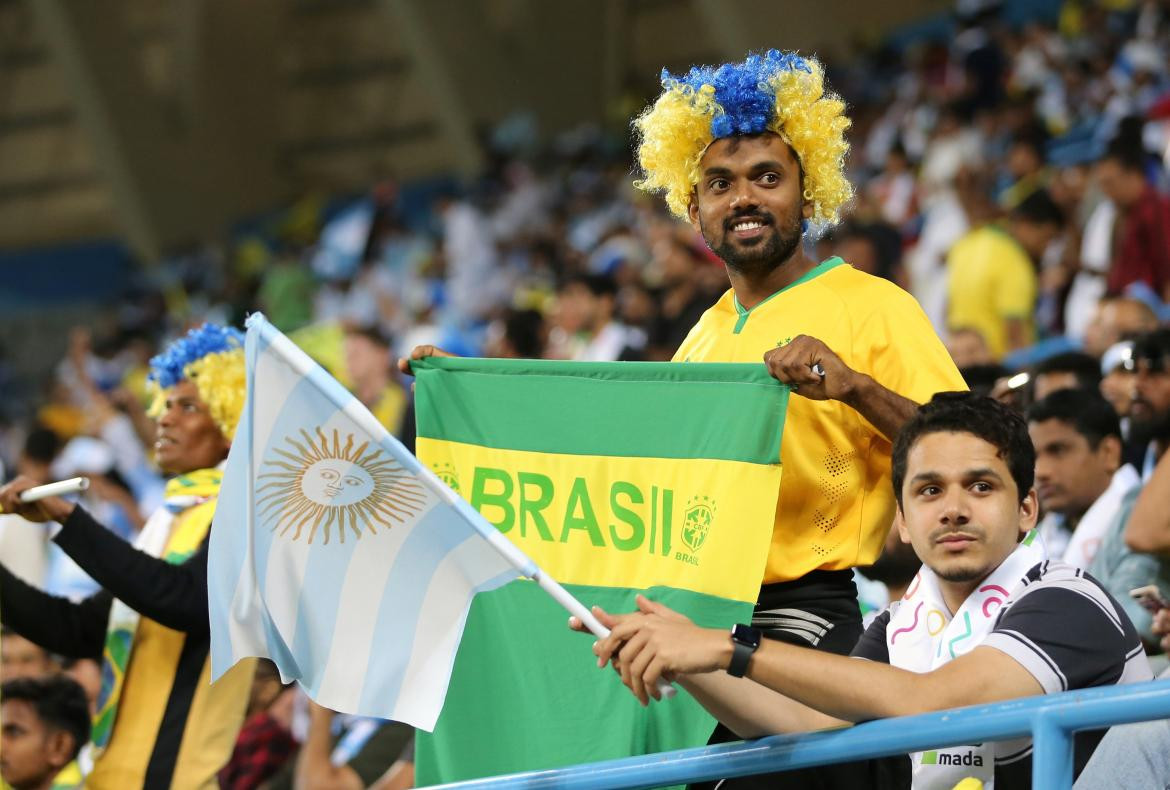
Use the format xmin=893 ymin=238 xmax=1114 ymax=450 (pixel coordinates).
xmin=852 ymin=562 xmax=1152 ymax=790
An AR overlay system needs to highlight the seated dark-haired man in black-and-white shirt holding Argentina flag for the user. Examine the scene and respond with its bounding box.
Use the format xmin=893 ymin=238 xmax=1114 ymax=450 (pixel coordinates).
xmin=580 ymin=393 xmax=1151 ymax=790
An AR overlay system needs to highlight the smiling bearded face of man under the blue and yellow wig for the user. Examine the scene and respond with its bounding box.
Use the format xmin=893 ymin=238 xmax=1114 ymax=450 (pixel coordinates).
xmin=689 ymin=132 xmax=812 ymax=274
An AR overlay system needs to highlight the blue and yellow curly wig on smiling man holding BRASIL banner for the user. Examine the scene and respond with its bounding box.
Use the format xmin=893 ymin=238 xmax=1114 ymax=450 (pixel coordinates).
xmin=634 ymin=49 xmax=853 ymax=225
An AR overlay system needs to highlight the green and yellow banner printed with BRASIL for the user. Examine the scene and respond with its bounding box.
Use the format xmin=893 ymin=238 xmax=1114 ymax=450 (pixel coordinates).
xmin=413 ymin=358 xmax=789 ymax=785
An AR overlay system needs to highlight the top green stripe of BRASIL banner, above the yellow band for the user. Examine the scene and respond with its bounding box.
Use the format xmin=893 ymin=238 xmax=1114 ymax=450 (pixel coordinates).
xmin=411 ymin=357 xmax=789 ymax=463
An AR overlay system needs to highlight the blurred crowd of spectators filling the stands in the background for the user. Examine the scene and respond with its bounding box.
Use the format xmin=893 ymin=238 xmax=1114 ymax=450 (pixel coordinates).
xmin=0 ymin=0 xmax=1170 ymax=788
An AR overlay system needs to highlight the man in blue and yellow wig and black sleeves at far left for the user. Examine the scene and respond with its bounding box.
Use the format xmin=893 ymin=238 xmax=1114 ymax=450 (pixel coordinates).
xmin=0 ymin=324 xmax=254 ymax=790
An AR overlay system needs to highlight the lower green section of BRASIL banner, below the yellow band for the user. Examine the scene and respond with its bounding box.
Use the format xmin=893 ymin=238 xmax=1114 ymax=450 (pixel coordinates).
xmin=415 ymin=581 xmax=751 ymax=786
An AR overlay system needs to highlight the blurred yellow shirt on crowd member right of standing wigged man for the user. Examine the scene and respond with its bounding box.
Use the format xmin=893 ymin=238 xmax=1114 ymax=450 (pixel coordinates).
xmin=947 ymin=225 xmax=1037 ymax=358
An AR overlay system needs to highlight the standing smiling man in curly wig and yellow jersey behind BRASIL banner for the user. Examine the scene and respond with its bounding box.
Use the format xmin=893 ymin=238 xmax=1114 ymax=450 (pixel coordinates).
xmin=634 ymin=50 xmax=965 ymax=786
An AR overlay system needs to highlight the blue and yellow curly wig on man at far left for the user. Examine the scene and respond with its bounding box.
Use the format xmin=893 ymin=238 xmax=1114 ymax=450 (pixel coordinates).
xmin=149 ymin=324 xmax=247 ymax=439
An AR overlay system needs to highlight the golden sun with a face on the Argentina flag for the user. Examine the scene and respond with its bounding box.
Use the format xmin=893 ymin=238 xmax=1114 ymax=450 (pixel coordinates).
xmin=256 ymin=428 xmax=426 ymax=544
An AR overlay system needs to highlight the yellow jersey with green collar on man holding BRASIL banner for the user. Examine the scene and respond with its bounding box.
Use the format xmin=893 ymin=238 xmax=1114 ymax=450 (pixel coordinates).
xmin=674 ymin=257 xmax=966 ymax=583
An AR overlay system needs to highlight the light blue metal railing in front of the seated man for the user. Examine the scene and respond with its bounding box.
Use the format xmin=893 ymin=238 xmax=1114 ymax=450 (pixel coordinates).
xmin=443 ymin=680 xmax=1170 ymax=790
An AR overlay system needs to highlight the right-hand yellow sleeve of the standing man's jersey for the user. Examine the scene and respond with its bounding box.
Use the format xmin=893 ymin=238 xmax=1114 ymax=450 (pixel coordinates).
xmin=855 ymin=282 xmax=968 ymax=404
